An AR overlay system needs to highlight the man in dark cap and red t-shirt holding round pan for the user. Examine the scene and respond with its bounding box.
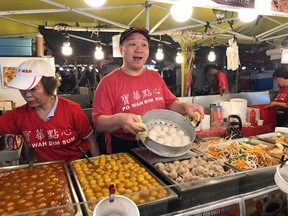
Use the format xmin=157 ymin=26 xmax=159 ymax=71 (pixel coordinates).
xmin=92 ymin=28 xmax=204 ymax=153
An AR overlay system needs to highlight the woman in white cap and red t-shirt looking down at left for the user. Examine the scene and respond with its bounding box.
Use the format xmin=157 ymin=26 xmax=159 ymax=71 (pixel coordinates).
xmin=0 ymin=59 xmax=100 ymax=163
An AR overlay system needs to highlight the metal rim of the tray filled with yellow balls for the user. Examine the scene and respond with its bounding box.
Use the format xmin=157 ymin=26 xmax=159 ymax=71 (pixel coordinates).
xmin=69 ymin=153 xmax=178 ymax=216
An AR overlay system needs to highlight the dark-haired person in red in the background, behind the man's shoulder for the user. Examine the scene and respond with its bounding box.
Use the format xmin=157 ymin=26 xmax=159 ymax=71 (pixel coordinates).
xmin=204 ymin=64 xmax=229 ymax=95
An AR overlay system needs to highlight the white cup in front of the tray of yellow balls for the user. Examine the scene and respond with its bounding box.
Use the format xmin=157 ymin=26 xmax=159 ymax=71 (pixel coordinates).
xmin=93 ymin=195 xmax=140 ymax=216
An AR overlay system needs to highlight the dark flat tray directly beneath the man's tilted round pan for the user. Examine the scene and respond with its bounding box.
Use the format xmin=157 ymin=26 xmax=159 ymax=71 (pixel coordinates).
xmin=131 ymin=147 xmax=202 ymax=165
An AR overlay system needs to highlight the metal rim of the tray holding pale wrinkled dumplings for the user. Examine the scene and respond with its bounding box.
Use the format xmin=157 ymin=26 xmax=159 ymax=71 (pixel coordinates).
xmin=153 ymin=156 xmax=245 ymax=192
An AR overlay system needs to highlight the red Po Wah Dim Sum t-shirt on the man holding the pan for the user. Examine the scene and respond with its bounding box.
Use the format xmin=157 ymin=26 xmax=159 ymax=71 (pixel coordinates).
xmin=92 ymin=68 xmax=177 ymax=143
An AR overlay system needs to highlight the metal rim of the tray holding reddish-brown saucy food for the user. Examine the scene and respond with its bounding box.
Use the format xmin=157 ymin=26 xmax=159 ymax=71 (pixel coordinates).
xmin=0 ymin=161 xmax=83 ymax=216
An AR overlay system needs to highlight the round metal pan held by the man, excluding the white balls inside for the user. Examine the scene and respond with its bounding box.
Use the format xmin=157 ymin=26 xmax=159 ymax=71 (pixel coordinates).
xmin=142 ymin=109 xmax=196 ymax=157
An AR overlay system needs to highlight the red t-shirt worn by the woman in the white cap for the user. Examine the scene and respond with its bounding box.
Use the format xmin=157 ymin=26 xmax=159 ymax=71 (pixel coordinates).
xmin=0 ymin=97 xmax=93 ymax=163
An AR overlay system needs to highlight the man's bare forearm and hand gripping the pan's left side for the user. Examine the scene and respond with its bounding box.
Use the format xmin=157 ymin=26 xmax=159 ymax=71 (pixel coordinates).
xmin=95 ymin=113 xmax=143 ymax=135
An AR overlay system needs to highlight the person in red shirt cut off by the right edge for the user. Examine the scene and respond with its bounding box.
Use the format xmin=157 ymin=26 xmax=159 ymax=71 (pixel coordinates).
xmin=266 ymin=66 xmax=288 ymax=127
